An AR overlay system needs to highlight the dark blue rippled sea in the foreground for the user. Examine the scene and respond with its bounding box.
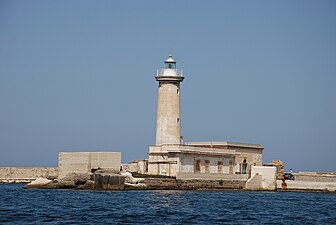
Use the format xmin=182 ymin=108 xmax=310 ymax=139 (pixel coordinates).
xmin=0 ymin=184 xmax=336 ymax=225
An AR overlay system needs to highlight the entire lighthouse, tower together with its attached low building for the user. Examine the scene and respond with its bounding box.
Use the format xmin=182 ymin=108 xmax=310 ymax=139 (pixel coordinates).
xmin=148 ymin=55 xmax=263 ymax=176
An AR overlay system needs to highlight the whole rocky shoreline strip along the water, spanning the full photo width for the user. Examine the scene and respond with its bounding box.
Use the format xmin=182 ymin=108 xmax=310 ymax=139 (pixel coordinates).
xmin=0 ymin=169 xmax=336 ymax=193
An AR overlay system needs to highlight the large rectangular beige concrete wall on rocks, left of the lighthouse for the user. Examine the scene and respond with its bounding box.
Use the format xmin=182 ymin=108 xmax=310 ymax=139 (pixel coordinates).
xmin=58 ymin=152 xmax=121 ymax=179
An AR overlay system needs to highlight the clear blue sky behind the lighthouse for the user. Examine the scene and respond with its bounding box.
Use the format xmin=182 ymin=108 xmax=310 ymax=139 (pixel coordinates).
xmin=0 ymin=0 xmax=336 ymax=171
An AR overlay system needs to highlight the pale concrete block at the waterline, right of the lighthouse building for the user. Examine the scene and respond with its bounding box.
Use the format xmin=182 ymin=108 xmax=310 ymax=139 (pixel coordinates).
xmin=248 ymin=166 xmax=277 ymax=190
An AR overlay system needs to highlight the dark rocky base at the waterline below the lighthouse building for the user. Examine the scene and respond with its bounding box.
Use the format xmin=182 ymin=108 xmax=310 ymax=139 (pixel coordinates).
xmin=25 ymin=170 xmax=246 ymax=190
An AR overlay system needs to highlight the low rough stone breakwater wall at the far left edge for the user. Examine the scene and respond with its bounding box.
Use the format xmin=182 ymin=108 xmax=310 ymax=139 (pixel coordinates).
xmin=0 ymin=167 xmax=58 ymax=184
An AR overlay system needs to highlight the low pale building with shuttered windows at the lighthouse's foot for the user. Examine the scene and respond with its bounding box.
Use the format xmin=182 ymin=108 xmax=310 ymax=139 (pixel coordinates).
xmin=148 ymin=145 xmax=262 ymax=176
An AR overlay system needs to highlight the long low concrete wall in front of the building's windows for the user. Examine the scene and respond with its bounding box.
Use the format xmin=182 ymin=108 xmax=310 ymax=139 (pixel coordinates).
xmin=176 ymin=172 xmax=248 ymax=181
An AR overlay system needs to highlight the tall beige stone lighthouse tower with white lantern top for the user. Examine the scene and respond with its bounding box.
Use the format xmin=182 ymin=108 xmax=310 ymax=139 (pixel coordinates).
xmin=155 ymin=55 xmax=184 ymax=146
